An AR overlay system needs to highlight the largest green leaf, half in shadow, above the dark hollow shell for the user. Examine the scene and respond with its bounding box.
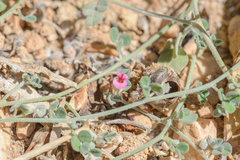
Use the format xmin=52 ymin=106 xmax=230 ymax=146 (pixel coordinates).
xmin=158 ymin=48 xmax=189 ymax=73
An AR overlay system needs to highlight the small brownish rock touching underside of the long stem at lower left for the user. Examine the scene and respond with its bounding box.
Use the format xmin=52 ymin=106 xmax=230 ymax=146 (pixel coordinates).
xmin=16 ymin=115 xmax=36 ymax=139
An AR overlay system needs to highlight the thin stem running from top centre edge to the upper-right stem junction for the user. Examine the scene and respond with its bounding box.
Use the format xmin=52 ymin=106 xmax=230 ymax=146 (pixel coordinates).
xmin=110 ymin=0 xmax=191 ymax=25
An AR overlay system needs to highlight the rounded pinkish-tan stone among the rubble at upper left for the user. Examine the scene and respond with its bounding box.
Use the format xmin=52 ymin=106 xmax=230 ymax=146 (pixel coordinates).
xmin=25 ymin=31 xmax=45 ymax=52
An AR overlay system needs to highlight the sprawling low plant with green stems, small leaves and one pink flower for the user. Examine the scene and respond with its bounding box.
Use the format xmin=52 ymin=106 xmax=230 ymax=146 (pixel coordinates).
xmin=0 ymin=0 xmax=240 ymax=159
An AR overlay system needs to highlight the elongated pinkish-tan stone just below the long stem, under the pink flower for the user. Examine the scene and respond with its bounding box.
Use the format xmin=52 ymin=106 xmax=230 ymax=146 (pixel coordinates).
xmin=127 ymin=111 xmax=152 ymax=128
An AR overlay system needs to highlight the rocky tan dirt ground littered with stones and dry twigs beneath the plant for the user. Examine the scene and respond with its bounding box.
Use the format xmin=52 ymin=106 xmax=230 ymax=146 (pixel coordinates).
xmin=0 ymin=0 xmax=240 ymax=160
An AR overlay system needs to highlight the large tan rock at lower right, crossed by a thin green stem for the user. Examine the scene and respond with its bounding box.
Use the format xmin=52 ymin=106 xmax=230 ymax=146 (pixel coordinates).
xmin=173 ymin=118 xmax=217 ymax=160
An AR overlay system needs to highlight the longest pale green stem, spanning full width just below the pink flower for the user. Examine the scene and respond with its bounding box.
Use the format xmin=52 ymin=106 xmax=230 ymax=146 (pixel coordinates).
xmin=0 ymin=62 xmax=240 ymax=123
